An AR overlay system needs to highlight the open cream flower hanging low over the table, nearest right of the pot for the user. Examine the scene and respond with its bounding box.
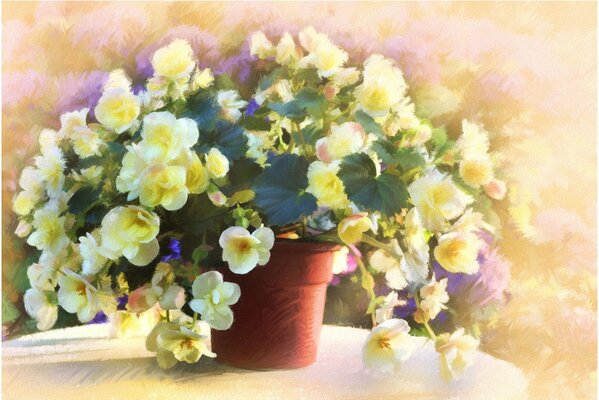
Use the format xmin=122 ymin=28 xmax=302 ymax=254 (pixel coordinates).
xmin=362 ymin=319 xmax=414 ymax=372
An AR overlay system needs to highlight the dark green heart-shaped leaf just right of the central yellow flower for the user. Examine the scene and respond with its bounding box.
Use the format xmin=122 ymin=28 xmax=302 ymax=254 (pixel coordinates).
xmin=337 ymin=153 xmax=408 ymax=216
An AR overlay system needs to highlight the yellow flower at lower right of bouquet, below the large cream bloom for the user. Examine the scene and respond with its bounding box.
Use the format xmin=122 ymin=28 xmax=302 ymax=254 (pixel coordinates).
xmin=435 ymin=232 xmax=481 ymax=274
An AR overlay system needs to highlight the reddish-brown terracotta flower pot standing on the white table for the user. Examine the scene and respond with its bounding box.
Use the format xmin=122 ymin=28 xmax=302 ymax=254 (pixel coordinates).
xmin=212 ymin=241 xmax=339 ymax=369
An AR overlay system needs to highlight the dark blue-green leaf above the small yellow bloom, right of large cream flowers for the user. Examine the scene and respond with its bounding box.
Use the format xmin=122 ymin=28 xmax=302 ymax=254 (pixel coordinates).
xmin=194 ymin=120 xmax=248 ymax=161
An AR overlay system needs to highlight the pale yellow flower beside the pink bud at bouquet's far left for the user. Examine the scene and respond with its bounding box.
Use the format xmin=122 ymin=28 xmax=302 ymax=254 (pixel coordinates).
xmin=27 ymin=201 xmax=69 ymax=254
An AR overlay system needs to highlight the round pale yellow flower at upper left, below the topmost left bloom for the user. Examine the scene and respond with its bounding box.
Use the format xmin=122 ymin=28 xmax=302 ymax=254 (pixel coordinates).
xmin=94 ymin=87 xmax=141 ymax=133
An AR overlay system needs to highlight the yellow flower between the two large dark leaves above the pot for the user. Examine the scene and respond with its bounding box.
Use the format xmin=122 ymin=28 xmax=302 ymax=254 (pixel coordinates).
xmin=306 ymin=161 xmax=349 ymax=208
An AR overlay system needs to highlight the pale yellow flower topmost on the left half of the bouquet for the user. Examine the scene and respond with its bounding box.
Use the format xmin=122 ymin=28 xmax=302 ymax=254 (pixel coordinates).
xmin=152 ymin=39 xmax=195 ymax=79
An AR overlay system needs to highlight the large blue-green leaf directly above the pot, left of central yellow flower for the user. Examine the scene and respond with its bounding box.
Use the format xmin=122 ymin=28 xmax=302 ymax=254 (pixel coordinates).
xmin=252 ymin=154 xmax=317 ymax=226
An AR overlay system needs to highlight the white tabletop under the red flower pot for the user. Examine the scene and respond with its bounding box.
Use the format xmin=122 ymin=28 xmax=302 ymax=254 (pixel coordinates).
xmin=2 ymin=325 xmax=527 ymax=400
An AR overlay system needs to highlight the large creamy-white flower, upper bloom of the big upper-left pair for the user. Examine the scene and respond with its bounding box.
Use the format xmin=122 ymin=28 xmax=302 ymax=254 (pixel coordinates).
xmin=139 ymin=111 xmax=199 ymax=163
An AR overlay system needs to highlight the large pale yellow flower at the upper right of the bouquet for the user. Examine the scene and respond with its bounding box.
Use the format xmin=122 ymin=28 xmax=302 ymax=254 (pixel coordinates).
xmin=355 ymin=54 xmax=407 ymax=118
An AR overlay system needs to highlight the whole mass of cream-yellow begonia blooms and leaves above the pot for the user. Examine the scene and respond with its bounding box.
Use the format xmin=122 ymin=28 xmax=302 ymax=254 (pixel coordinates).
xmin=14 ymin=28 xmax=506 ymax=379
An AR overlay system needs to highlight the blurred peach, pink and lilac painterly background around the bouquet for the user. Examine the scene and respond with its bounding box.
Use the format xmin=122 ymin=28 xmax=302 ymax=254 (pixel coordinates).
xmin=2 ymin=2 xmax=597 ymax=399
